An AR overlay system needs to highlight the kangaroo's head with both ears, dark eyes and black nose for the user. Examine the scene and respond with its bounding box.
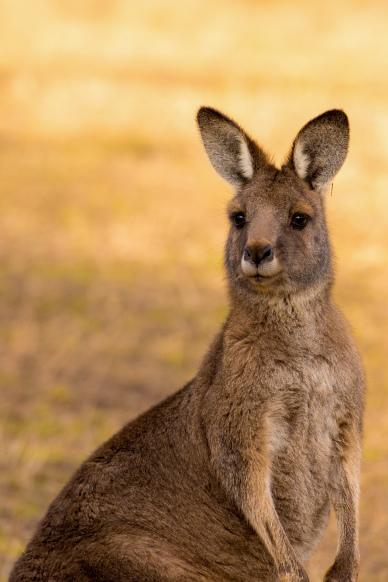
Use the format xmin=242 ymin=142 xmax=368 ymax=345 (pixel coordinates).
xmin=198 ymin=107 xmax=349 ymax=304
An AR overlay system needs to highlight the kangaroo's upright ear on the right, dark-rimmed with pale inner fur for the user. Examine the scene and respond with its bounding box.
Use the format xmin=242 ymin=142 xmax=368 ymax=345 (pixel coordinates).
xmin=288 ymin=109 xmax=349 ymax=191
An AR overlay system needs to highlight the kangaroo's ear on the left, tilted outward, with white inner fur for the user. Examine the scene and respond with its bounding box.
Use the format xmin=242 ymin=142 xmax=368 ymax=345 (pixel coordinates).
xmin=197 ymin=107 xmax=268 ymax=187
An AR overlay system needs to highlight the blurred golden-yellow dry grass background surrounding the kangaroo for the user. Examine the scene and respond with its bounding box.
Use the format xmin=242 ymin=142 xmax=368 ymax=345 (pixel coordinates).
xmin=0 ymin=0 xmax=388 ymax=582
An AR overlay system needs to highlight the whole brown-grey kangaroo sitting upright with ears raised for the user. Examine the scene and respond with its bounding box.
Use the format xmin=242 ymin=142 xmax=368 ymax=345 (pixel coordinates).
xmin=10 ymin=107 xmax=364 ymax=582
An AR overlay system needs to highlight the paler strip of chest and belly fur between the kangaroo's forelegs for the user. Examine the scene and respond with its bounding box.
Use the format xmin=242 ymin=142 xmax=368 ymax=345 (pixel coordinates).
xmin=267 ymin=356 xmax=339 ymax=552
